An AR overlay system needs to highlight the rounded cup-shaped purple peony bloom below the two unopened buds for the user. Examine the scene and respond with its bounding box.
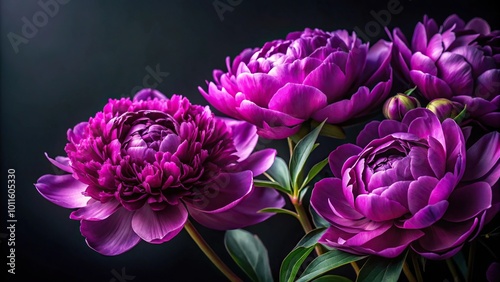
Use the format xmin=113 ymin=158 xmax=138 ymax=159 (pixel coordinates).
xmin=311 ymin=108 xmax=500 ymax=259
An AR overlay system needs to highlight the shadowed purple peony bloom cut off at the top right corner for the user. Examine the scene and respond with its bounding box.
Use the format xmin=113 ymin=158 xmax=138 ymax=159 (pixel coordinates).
xmin=392 ymin=15 xmax=500 ymax=130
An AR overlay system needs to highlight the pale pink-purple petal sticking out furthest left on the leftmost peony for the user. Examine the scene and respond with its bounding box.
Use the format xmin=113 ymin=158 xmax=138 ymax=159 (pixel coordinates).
xmin=35 ymin=174 xmax=90 ymax=209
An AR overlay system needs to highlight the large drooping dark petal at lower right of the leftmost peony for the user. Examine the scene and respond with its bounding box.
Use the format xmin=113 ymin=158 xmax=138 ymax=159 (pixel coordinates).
xmin=187 ymin=187 xmax=285 ymax=230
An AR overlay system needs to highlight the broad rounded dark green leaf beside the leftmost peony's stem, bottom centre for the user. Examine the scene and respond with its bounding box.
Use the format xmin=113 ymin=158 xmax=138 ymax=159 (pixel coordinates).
xmin=224 ymin=229 xmax=273 ymax=281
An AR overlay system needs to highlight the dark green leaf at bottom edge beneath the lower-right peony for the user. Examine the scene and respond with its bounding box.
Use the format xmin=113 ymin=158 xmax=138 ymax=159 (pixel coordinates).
xmin=356 ymin=252 xmax=408 ymax=282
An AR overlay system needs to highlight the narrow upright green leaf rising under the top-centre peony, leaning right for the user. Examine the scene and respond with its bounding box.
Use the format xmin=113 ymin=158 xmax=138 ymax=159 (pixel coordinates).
xmin=290 ymin=121 xmax=325 ymax=191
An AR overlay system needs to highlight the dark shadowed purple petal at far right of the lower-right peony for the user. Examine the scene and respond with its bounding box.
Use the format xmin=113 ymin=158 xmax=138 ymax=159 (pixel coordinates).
xmin=443 ymin=182 xmax=492 ymax=222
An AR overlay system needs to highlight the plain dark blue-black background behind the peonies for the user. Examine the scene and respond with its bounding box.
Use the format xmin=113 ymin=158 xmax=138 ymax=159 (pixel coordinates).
xmin=0 ymin=0 xmax=500 ymax=281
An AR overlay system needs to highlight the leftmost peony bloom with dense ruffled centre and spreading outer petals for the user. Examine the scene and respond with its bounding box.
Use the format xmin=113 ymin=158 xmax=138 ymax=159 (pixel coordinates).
xmin=35 ymin=89 xmax=284 ymax=255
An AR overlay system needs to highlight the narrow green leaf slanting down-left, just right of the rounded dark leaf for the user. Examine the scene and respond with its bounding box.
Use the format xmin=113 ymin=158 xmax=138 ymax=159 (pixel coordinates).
xmin=280 ymin=228 xmax=326 ymax=282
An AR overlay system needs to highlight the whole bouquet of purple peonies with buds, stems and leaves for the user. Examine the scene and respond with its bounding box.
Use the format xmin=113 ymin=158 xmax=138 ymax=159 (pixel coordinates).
xmin=35 ymin=15 xmax=500 ymax=281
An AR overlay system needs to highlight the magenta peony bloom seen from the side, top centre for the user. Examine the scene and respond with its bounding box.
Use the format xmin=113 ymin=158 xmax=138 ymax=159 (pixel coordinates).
xmin=199 ymin=29 xmax=392 ymax=139
